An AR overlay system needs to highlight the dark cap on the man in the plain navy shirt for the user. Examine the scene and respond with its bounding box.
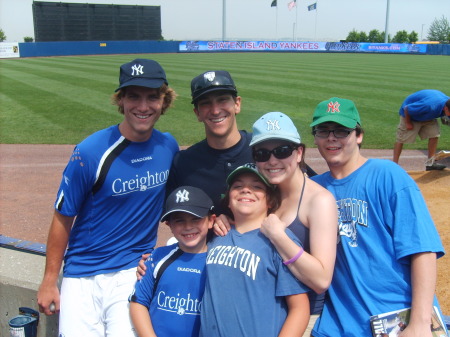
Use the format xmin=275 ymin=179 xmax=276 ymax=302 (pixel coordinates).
xmin=191 ymin=70 xmax=237 ymax=104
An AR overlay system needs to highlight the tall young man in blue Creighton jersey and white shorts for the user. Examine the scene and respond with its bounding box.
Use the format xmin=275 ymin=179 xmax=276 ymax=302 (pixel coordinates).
xmin=38 ymin=59 xmax=178 ymax=337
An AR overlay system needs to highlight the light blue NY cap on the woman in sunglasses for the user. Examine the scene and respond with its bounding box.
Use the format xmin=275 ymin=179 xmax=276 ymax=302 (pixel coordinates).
xmin=250 ymin=112 xmax=302 ymax=146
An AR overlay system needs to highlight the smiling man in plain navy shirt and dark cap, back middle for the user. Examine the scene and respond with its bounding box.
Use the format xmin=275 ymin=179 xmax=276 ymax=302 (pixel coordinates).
xmin=167 ymin=70 xmax=316 ymax=215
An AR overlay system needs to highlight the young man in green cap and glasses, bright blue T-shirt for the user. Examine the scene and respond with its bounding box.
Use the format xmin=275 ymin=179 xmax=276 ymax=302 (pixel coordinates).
xmin=311 ymin=97 xmax=444 ymax=337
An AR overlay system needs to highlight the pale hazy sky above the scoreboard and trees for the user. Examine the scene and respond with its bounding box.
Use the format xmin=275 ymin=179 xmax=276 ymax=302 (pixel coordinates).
xmin=0 ymin=0 xmax=450 ymax=42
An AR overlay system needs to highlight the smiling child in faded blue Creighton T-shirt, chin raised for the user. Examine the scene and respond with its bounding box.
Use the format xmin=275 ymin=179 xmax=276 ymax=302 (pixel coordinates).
xmin=200 ymin=164 xmax=309 ymax=337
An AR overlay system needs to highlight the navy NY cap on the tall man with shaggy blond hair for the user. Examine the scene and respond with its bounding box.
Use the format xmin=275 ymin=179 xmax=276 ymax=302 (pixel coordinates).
xmin=116 ymin=59 xmax=169 ymax=91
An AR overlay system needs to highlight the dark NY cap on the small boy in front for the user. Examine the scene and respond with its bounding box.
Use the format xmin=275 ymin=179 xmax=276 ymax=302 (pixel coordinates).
xmin=161 ymin=186 xmax=214 ymax=222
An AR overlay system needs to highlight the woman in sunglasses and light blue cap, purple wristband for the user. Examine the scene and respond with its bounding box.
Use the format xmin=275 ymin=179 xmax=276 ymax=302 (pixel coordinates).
xmin=214 ymin=112 xmax=337 ymax=336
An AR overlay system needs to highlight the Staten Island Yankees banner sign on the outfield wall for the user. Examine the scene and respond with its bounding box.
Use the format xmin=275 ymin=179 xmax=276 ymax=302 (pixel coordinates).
xmin=179 ymin=41 xmax=427 ymax=54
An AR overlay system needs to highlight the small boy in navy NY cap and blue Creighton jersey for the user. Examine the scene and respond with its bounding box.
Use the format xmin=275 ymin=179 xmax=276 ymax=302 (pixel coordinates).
xmin=130 ymin=186 xmax=215 ymax=337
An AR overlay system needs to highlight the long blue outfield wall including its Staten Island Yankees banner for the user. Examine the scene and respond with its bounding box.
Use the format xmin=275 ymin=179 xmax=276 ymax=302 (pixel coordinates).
xmin=19 ymin=41 xmax=450 ymax=57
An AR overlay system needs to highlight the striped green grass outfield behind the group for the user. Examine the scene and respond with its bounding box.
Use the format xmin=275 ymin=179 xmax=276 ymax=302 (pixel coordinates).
xmin=0 ymin=53 xmax=450 ymax=150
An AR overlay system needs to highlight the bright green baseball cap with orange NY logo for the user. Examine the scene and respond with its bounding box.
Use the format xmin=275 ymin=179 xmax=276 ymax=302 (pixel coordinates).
xmin=309 ymin=97 xmax=361 ymax=129
